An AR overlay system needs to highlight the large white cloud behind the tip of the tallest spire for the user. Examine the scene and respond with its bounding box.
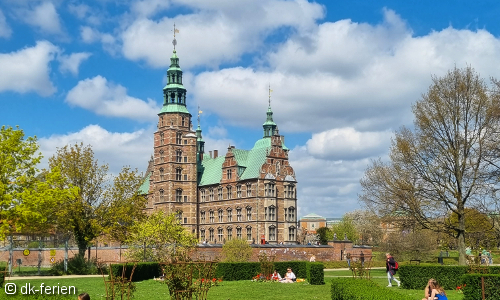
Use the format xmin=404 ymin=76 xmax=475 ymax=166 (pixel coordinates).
xmin=121 ymin=0 xmax=324 ymax=68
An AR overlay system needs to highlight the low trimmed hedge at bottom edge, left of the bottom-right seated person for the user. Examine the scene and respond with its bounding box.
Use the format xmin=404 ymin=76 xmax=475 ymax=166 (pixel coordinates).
xmin=331 ymin=278 xmax=414 ymax=300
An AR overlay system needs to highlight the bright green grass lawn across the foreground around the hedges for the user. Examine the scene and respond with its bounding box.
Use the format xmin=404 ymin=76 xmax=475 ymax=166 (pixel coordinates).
xmin=0 ymin=269 xmax=463 ymax=300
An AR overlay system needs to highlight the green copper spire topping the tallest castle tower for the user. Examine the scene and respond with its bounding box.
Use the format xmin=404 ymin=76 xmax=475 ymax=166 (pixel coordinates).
xmin=159 ymin=25 xmax=189 ymax=114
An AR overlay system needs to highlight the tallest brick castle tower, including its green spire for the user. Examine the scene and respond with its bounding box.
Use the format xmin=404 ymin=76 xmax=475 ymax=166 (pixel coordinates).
xmin=149 ymin=46 xmax=201 ymax=233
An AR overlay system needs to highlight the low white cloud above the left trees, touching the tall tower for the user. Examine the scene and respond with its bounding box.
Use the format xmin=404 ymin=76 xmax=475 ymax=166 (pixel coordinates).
xmin=39 ymin=125 xmax=154 ymax=174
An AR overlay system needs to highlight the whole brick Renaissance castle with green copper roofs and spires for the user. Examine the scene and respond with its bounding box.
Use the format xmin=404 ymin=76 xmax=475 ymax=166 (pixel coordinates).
xmin=140 ymin=48 xmax=297 ymax=244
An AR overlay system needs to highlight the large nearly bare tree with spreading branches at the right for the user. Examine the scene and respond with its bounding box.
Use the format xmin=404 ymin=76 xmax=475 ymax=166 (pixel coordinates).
xmin=360 ymin=67 xmax=500 ymax=265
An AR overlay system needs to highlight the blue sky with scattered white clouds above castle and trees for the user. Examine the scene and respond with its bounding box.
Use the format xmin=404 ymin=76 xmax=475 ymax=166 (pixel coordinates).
xmin=0 ymin=0 xmax=500 ymax=217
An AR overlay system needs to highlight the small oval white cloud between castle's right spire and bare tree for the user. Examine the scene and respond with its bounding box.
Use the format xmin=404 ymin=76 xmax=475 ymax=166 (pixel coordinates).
xmin=306 ymin=127 xmax=392 ymax=160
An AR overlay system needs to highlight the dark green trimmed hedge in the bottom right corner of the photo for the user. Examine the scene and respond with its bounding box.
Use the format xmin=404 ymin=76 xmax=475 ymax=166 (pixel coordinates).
xmin=462 ymin=274 xmax=500 ymax=300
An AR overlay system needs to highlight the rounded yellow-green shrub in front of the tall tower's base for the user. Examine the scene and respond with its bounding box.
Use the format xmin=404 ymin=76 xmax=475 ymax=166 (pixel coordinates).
xmin=126 ymin=210 xmax=196 ymax=262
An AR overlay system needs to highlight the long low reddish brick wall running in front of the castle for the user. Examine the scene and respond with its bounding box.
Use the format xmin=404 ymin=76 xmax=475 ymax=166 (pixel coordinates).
xmin=0 ymin=241 xmax=372 ymax=267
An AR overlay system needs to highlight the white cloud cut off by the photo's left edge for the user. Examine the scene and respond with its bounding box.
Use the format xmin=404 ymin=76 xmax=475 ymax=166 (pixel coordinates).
xmin=0 ymin=41 xmax=59 ymax=97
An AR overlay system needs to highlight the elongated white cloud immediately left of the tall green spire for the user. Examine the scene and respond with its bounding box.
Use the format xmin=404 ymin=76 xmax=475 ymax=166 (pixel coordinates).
xmin=66 ymin=76 xmax=160 ymax=121
